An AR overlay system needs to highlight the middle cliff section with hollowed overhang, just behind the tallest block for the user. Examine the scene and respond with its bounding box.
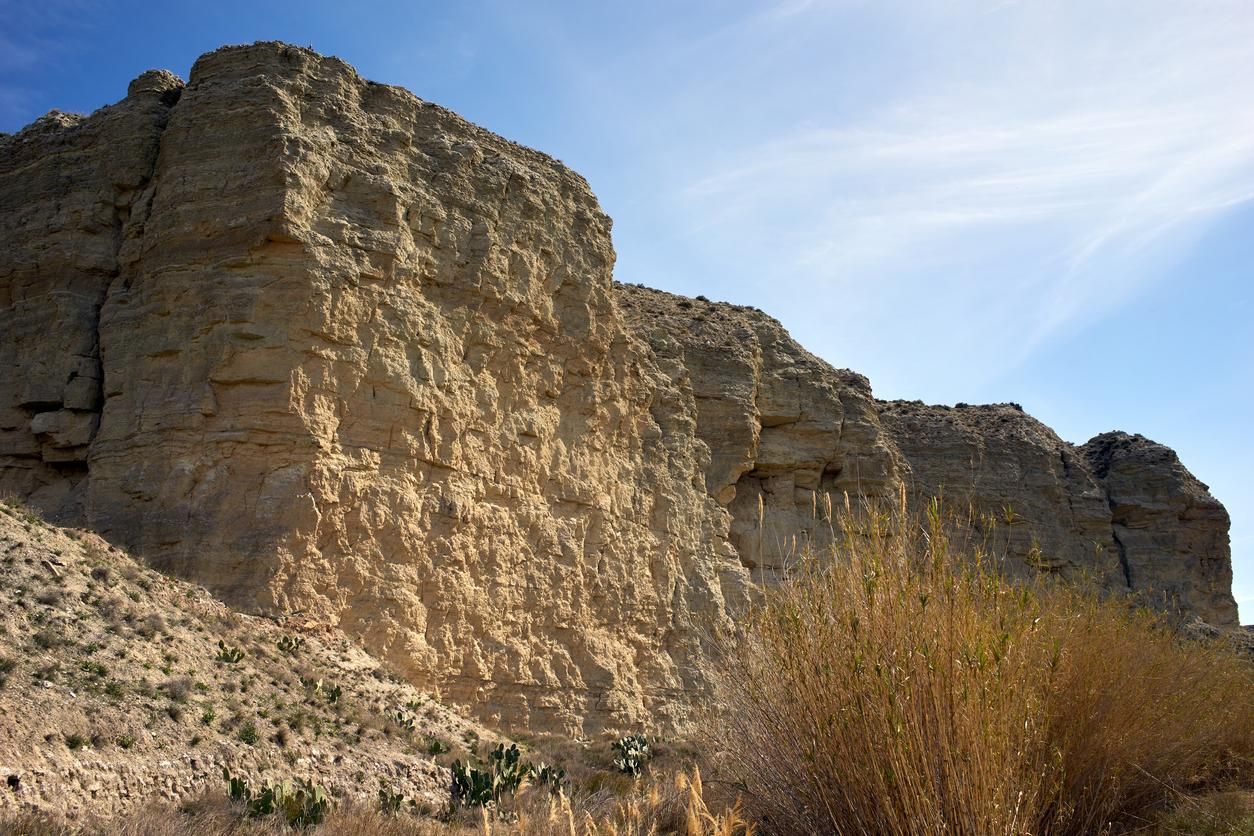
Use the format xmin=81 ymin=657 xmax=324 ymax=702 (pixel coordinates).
xmin=618 ymin=285 xmax=904 ymax=583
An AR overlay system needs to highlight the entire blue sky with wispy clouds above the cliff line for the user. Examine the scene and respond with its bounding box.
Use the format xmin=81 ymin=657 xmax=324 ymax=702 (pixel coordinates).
xmin=0 ymin=0 xmax=1254 ymax=622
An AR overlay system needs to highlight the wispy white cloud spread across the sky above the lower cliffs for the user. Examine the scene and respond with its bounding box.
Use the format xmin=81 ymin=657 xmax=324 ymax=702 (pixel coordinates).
xmin=675 ymin=0 xmax=1254 ymax=383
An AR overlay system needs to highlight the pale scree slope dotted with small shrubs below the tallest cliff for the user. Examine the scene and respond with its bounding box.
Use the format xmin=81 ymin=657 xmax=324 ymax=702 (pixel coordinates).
xmin=0 ymin=501 xmax=497 ymax=818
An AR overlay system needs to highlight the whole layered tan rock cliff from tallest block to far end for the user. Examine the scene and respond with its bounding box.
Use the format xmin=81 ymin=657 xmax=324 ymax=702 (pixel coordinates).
xmin=0 ymin=44 xmax=1235 ymax=731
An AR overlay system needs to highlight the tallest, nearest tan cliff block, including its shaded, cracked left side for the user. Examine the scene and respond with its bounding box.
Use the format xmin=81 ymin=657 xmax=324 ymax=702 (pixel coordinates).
xmin=0 ymin=44 xmax=747 ymax=731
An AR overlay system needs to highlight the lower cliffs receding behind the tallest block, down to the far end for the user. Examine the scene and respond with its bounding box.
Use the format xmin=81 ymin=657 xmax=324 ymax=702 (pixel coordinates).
xmin=618 ymin=285 xmax=1236 ymax=627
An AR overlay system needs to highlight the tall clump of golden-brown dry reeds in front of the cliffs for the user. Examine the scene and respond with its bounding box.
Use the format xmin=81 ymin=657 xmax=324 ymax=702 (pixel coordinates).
xmin=710 ymin=500 xmax=1254 ymax=836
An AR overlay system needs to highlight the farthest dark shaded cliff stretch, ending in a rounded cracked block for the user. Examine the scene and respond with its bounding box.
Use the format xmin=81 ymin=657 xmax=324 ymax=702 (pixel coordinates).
xmin=880 ymin=401 xmax=1238 ymax=627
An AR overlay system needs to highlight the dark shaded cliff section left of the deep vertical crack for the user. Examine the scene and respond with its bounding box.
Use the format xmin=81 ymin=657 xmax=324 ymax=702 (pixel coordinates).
xmin=0 ymin=71 xmax=183 ymax=511
